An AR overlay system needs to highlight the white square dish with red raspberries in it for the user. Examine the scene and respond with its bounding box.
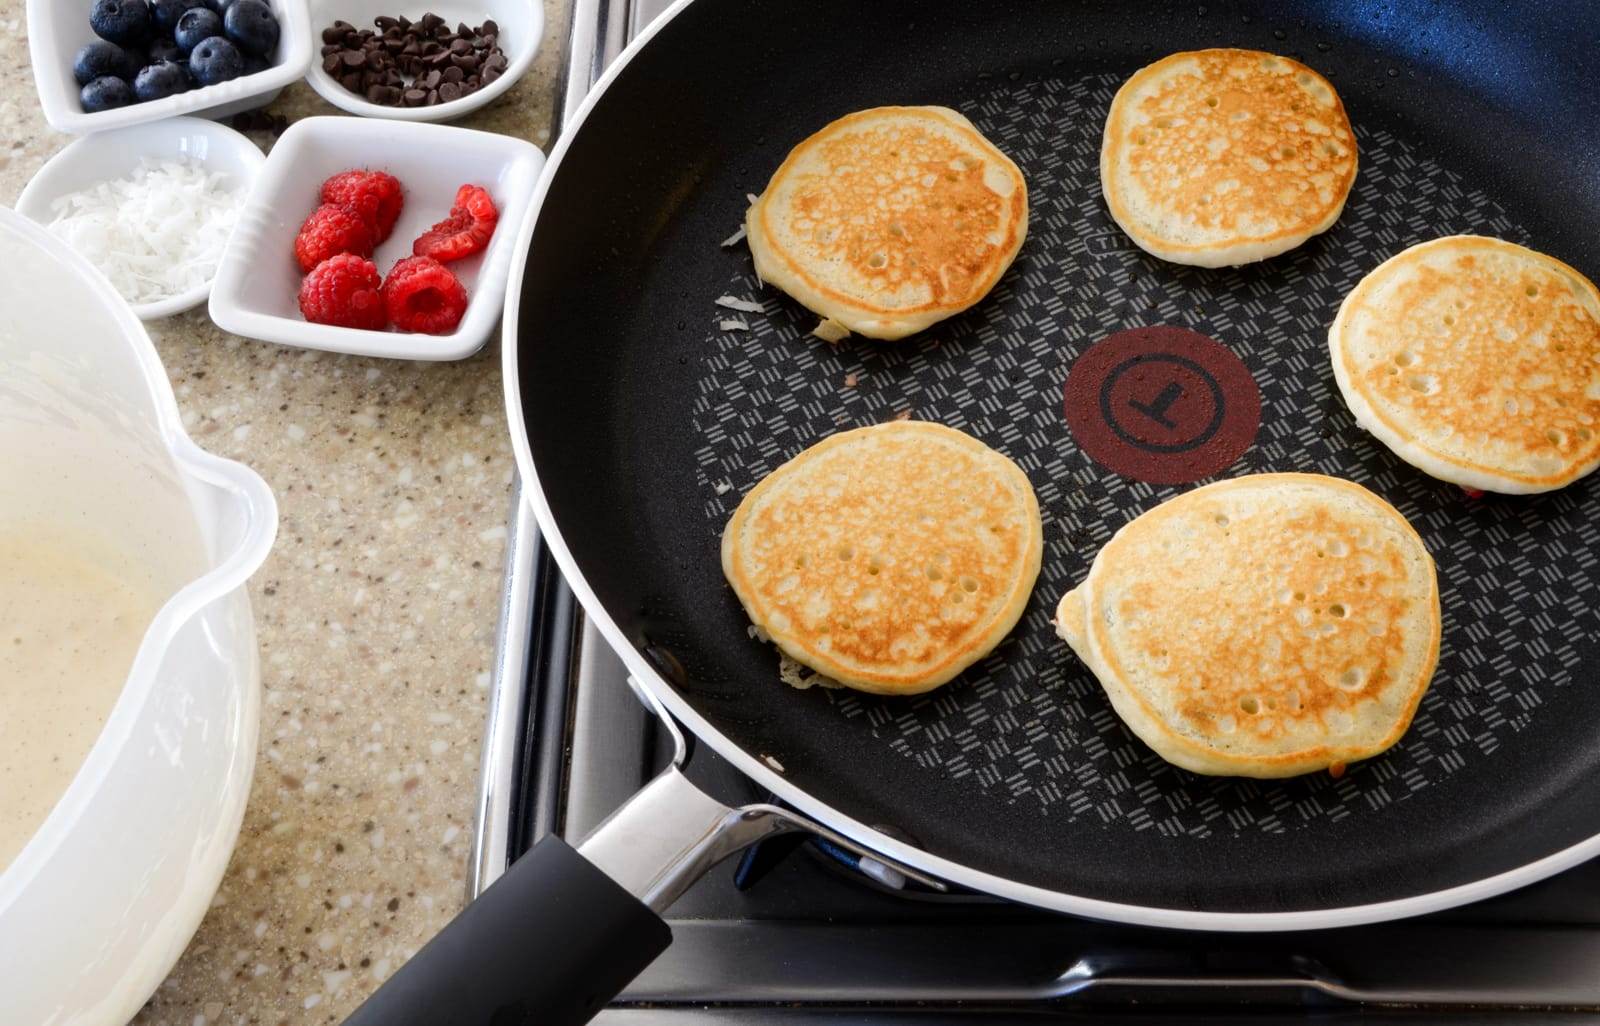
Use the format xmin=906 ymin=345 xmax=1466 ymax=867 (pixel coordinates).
xmin=211 ymin=117 xmax=544 ymax=360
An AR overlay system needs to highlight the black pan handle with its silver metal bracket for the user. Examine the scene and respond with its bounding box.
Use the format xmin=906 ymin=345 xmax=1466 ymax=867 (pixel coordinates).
xmin=344 ymin=707 xmax=944 ymax=1026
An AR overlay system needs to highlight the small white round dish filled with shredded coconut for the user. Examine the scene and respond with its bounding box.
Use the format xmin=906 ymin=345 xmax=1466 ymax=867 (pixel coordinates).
xmin=16 ymin=117 xmax=266 ymax=320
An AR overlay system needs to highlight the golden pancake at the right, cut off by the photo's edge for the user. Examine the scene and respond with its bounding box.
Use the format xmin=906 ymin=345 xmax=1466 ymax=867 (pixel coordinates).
xmin=1328 ymin=235 xmax=1600 ymax=493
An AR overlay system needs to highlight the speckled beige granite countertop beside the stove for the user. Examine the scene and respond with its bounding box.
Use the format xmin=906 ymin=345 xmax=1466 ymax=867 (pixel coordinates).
xmin=0 ymin=0 xmax=568 ymax=1026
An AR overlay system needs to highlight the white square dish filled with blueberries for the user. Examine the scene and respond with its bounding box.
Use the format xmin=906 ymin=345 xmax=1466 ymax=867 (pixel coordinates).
xmin=27 ymin=0 xmax=312 ymax=133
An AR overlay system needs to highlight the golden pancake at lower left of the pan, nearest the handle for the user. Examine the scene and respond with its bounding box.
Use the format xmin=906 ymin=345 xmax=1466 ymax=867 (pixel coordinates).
xmin=722 ymin=421 xmax=1043 ymax=695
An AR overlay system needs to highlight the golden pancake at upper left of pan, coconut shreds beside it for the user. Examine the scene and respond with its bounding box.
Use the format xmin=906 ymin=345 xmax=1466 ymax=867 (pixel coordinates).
xmin=746 ymin=107 xmax=1027 ymax=341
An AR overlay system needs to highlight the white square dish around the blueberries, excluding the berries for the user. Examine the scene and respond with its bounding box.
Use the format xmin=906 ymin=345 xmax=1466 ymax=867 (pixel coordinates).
xmin=27 ymin=0 xmax=317 ymax=134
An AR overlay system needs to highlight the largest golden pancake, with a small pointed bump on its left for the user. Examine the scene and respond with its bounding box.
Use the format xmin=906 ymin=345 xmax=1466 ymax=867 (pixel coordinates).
xmin=1056 ymin=474 xmax=1440 ymax=778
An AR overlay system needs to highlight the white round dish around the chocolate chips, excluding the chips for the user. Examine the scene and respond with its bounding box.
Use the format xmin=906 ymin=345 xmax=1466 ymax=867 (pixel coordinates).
xmin=306 ymin=0 xmax=544 ymax=122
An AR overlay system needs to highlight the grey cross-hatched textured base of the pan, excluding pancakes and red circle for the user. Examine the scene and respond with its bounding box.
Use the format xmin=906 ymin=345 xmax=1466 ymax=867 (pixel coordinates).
xmin=691 ymin=74 xmax=1600 ymax=836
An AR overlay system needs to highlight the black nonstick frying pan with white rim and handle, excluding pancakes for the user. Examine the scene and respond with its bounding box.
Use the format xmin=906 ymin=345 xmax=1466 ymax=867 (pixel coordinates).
xmin=350 ymin=0 xmax=1600 ymax=1023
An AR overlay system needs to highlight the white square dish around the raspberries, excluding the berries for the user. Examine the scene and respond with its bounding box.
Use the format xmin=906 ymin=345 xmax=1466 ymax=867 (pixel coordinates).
xmin=210 ymin=117 xmax=544 ymax=360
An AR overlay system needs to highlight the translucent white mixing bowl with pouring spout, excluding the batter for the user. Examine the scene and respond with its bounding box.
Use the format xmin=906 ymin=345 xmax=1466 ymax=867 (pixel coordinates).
xmin=0 ymin=208 xmax=277 ymax=1026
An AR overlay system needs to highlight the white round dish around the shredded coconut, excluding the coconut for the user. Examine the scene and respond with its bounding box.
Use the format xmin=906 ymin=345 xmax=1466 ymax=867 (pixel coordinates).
xmin=16 ymin=117 xmax=267 ymax=320
